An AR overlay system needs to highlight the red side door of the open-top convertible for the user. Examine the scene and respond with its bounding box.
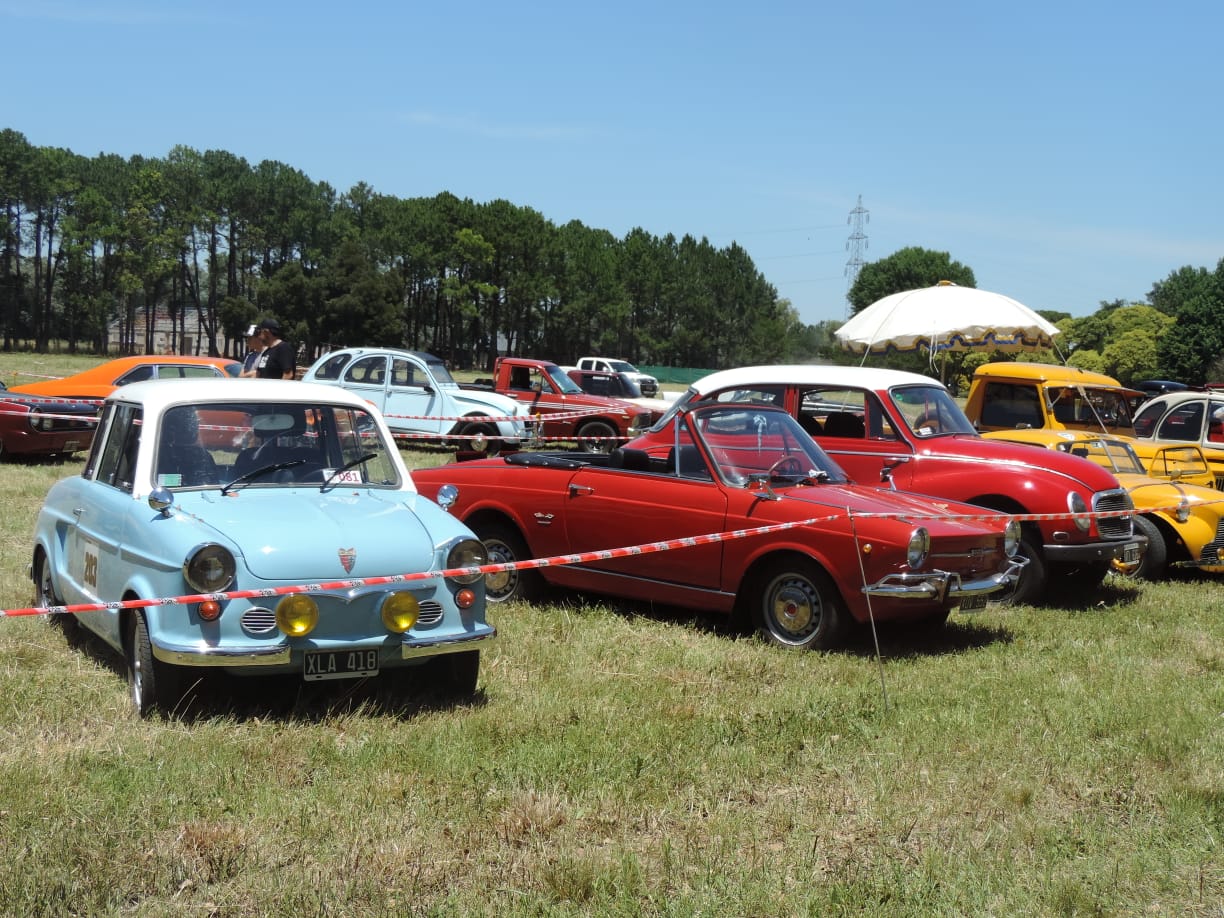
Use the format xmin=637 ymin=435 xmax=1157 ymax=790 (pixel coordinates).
xmin=564 ymin=457 xmax=727 ymax=590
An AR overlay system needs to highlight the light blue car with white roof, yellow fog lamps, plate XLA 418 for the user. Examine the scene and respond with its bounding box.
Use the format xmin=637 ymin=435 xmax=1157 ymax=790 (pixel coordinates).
xmin=31 ymin=379 xmax=497 ymax=715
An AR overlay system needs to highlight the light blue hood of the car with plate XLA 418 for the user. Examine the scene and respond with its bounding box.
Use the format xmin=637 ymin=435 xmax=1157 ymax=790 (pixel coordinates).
xmin=174 ymin=487 xmax=435 ymax=583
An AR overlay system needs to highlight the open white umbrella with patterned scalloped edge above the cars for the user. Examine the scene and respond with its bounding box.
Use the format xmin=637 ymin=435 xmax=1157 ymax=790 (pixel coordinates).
xmin=834 ymin=280 xmax=1059 ymax=357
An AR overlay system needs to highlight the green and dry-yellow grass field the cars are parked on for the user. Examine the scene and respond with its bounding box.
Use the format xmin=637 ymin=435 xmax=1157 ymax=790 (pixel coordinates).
xmin=0 ymin=355 xmax=1224 ymax=916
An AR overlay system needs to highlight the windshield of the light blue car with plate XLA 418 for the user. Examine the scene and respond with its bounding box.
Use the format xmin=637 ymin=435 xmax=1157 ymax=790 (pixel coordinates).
xmin=153 ymin=401 xmax=399 ymax=490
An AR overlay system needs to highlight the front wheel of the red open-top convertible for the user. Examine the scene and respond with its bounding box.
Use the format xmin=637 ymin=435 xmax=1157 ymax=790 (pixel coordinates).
xmin=750 ymin=557 xmax=849 ymax=650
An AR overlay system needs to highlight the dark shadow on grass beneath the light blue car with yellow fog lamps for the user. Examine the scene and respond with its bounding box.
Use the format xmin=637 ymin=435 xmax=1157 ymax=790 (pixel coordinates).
xmin=54 ymin=622 xmax=486 ymax=723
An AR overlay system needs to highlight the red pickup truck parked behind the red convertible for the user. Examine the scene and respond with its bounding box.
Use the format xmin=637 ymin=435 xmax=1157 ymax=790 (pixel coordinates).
xmin=469 ymin=357 xmax=650 ymax=453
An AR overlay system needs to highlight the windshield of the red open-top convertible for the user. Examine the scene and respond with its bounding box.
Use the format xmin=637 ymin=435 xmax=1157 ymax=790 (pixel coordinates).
xmin=673 ymin=404 xmax=847 ymax=487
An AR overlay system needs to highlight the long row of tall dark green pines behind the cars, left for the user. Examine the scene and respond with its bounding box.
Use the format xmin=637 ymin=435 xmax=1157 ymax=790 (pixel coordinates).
xmin=0 ymin=129 xmax=815 ymax=367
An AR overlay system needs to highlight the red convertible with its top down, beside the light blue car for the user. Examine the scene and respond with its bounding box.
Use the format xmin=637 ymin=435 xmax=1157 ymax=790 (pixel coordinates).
xmin=412 ymin=404 xmax=1024 ymax=649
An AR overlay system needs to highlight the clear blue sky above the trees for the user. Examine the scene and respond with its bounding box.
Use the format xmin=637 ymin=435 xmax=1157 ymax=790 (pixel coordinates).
xmin=0 ymin=0 xmax=1224 ymax=322
